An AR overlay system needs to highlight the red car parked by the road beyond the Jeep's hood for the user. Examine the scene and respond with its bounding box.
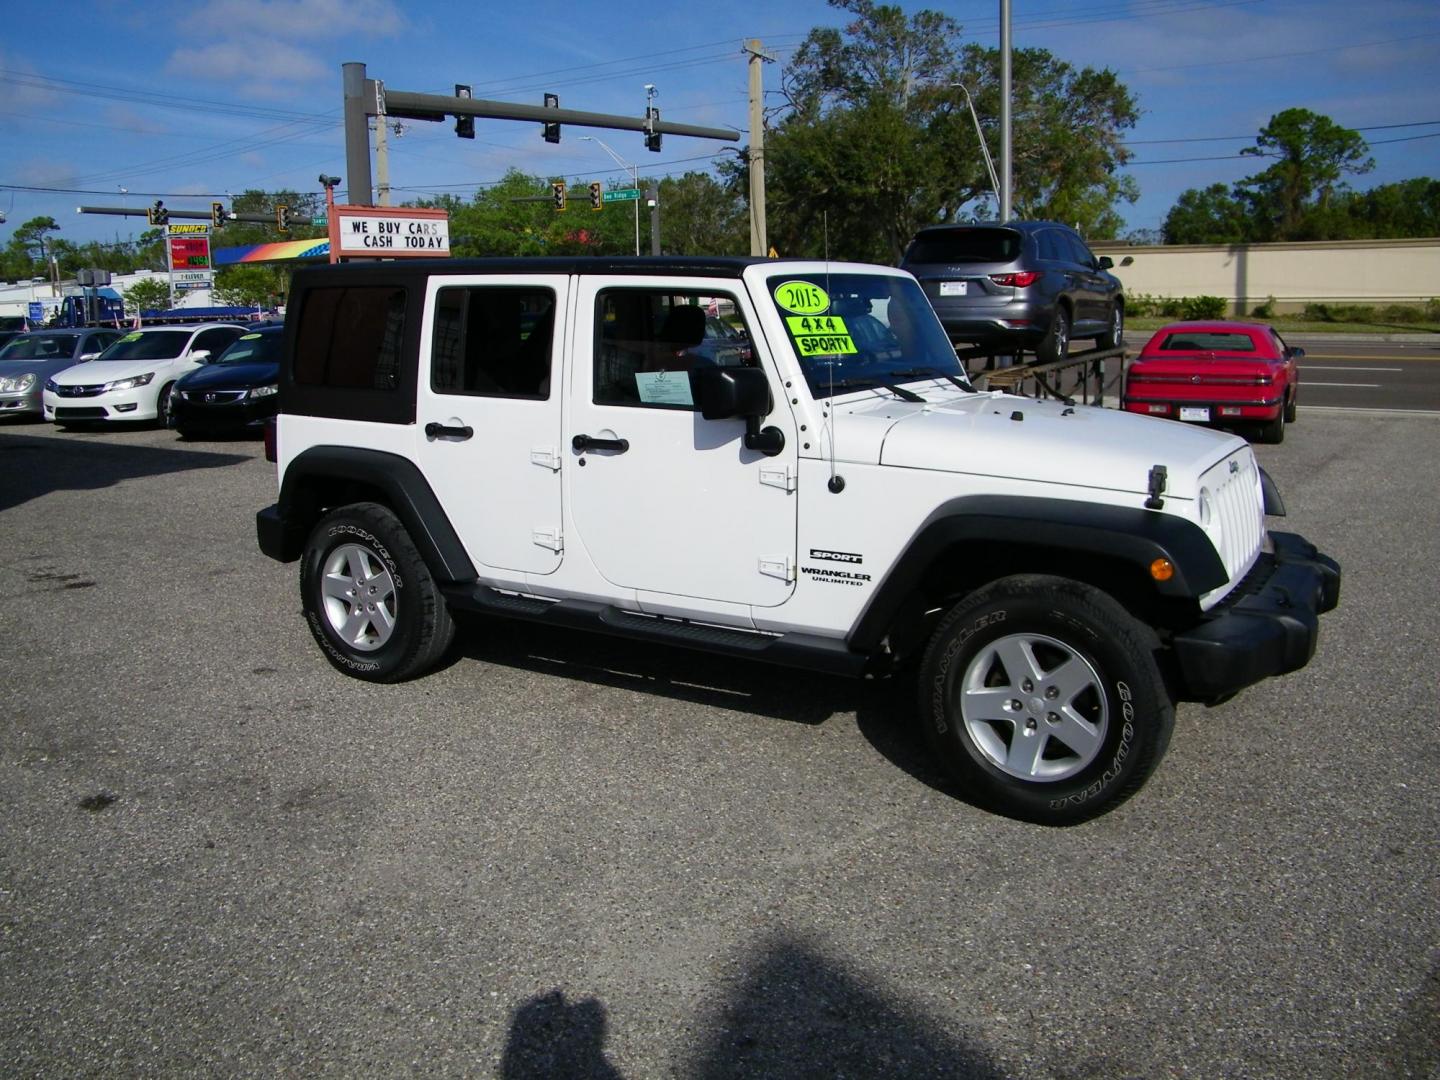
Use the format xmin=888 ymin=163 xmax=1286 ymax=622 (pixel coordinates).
xmin=1120 ymin=323 xmax=1305 ymax=442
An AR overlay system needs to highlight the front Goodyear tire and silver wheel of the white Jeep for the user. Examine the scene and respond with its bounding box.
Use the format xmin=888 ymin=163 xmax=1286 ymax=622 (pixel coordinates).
xmin=920 ymin=575 xmax=1175 ymax=825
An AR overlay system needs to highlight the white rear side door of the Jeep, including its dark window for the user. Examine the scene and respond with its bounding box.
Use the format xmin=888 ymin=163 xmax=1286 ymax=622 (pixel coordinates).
xmin=415 ymin=274 xmax=570 ymax=577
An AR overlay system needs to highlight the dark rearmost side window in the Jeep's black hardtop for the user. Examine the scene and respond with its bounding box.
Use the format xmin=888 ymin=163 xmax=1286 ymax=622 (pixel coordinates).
xmin=295 ymin=285 xmax=405 ymax=390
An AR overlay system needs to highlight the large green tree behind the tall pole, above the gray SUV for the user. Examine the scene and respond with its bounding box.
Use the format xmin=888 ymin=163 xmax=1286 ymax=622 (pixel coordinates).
xmin=760 ymin=0 xmax=1138 ymax=261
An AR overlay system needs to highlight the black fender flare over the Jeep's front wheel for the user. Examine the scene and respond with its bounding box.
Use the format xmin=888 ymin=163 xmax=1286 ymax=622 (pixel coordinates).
xmin=848 ymin=495 xmax=1228 ymax=652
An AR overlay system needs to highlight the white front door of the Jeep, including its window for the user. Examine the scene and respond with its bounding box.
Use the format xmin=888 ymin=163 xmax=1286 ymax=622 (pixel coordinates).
xmin=566 ymin=275 xmax=798 ymax=609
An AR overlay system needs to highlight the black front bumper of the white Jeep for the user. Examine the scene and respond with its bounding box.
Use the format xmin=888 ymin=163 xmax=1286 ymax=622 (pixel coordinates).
xmin=1171 ymin=533 xmax=1341 ymax=701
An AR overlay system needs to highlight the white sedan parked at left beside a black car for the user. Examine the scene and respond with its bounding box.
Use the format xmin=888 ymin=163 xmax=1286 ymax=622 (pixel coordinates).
xmin=42 ymin=323 xmax=245 ymax=423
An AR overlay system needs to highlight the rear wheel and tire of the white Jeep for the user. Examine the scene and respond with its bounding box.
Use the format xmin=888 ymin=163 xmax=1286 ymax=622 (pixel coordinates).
xmin=300 ymin=503 xmax=455 ymax=683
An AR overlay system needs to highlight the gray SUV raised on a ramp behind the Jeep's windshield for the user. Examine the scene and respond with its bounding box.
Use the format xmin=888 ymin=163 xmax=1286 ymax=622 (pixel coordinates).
xmin=900 ymin=222 xmax=1125 ymax=360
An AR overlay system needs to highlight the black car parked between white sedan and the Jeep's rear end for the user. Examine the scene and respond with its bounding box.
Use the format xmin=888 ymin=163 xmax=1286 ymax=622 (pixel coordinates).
xmin=170 ymin=325 xmax=285 ymax=439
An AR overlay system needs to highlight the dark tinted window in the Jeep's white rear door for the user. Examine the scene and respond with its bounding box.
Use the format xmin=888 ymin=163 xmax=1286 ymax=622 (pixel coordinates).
xmin=431 ymin=287 xmax=554 ymax=400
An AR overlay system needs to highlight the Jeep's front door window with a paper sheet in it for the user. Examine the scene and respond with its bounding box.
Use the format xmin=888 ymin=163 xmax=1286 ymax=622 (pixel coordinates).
xmin=595 ymin=289 xmax=755 ymax=409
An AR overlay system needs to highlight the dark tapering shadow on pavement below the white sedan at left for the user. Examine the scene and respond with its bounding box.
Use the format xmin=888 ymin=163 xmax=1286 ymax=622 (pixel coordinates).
xmin=0 ymin=429 xmax=251 ymax=510
